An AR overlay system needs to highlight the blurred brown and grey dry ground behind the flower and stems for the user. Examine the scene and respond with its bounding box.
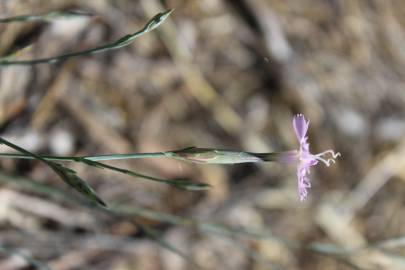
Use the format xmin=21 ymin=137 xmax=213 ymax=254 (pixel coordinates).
xmin=0 ymin=0 xmax=405 ymax=270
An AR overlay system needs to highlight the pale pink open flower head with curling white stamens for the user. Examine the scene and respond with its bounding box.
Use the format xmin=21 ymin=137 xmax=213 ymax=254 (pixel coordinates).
xmin=293 ymin=114 xmax=340 ymax=201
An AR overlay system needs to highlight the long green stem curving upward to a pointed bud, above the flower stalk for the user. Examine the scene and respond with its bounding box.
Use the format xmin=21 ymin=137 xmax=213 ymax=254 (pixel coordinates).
xmin=0 ymin=10 xmax=173 ymax=66
